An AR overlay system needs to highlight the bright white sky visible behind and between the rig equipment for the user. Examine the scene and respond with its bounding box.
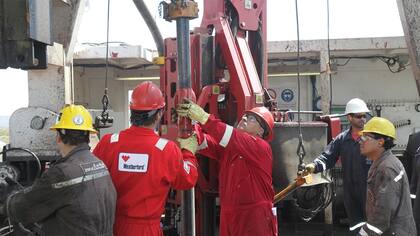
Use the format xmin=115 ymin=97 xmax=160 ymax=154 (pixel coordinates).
xmin=0 ymin=0 xmax=403 ymax=116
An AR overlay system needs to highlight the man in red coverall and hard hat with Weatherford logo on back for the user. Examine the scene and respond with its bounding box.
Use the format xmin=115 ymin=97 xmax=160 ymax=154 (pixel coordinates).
xmin=93 ymin=82 xmax=198 ymax=236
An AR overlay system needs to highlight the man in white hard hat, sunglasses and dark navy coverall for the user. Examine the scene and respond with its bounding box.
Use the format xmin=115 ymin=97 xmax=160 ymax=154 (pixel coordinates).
xmin=305 ymin=98 xmax=372 ymax=235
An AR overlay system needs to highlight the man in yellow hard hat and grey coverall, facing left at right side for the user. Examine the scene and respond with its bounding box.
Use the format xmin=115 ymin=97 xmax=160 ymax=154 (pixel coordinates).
xmin=359 ymin=117 xmax=416 ymax=236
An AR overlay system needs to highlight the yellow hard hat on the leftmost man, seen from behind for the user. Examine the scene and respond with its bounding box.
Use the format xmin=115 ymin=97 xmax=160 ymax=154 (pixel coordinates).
xmin=50 ymin=104 xmax=97 ymax=133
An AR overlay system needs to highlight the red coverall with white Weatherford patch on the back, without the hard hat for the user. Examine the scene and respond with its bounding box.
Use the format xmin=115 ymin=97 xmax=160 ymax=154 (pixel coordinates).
xmin=94 ymin=126 xmax=197 ymax=236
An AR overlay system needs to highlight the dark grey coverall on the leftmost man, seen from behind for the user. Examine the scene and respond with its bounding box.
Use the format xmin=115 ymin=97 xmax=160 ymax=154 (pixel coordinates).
xmin=6 ymin=144 xmax=116 ymax=236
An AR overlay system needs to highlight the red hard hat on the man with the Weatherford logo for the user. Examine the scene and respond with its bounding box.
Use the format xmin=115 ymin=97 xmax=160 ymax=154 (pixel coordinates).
xmin=130 ymin=81 xmax=165 ymax=111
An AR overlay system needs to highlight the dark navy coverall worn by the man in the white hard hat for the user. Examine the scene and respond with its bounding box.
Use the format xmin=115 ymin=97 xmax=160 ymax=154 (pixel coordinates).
xmin=314 ymin=129 xmax=372 ymax=231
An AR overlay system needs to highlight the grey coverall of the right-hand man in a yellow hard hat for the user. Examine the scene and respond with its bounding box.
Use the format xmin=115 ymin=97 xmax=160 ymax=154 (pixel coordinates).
xmin=363 ymin=150 xmax=416 ymax=236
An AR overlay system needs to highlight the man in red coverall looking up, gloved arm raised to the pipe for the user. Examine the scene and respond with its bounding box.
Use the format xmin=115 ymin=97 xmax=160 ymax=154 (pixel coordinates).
xmin=177 ymin=100 xmax=277 ymax=236
